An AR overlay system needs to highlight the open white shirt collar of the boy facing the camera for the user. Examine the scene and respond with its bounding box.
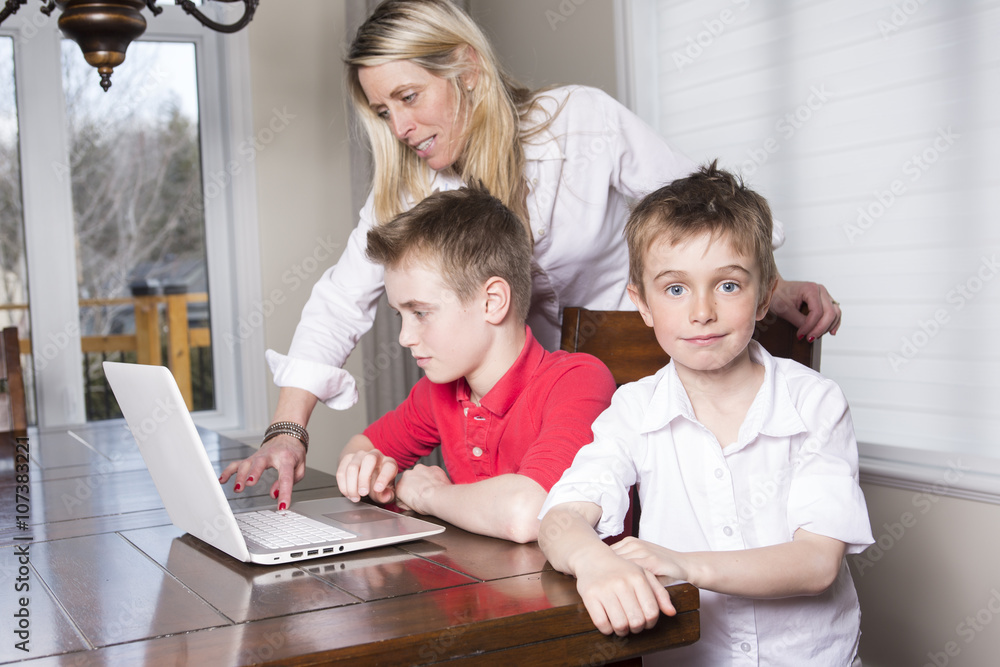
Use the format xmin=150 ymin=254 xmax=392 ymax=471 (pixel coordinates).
xmin=640 ymin=340 xmax=806 ymax=446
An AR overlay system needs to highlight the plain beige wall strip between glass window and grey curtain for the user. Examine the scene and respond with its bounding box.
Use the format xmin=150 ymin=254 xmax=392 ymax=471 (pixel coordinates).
xmin=248 ymin=0 xmax=365 ymax=472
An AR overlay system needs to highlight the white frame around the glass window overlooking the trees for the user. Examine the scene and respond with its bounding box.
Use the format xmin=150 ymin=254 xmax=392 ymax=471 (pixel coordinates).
xmin=0 ymin=6 xmax=267 ymax=438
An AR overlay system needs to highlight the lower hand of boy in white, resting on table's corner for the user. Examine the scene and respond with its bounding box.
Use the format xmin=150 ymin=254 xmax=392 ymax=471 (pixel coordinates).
xmin=576 ymin=545 xmax=677 ymax=637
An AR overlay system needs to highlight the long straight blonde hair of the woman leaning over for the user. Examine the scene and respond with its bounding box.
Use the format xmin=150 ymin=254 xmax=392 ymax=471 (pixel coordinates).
xmin=345 ymin=0 xmax=539 ymax=232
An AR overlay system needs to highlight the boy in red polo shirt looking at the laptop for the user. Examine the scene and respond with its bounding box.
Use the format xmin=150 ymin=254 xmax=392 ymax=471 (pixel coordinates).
xmin=337 ymin=183 xmax=615 ymax=542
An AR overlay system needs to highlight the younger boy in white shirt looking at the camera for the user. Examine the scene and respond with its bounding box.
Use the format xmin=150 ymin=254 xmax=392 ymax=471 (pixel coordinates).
xmin=539 ymin=163 xmax=873 ymax=667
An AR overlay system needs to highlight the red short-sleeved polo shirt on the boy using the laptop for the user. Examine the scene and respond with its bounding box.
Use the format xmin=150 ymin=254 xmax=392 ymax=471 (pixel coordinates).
xmin=364 ymin=328 xmax=615 ymax=491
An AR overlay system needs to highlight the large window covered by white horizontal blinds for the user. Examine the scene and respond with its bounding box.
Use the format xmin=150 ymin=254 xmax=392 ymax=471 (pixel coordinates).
xmin=620 ymin=0 xmax=1000 ymax=499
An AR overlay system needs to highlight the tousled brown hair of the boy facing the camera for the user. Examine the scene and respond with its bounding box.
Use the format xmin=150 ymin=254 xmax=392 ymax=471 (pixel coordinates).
xmin=625 ymin=161 xmax=778 ymax=303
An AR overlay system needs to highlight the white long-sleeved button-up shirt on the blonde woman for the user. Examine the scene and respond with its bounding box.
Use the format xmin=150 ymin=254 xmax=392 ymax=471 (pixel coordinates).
xmin=267 ymin=86 xmax=784 ymax=408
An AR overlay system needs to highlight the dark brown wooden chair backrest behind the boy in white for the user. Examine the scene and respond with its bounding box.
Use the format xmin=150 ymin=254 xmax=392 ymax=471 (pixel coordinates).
xmin=561 ymin=308 xmax=820 ymax=384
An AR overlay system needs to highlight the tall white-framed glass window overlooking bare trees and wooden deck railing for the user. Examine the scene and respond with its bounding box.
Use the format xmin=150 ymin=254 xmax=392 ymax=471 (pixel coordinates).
xmin=0 ymin=6 xmax=266 ymax=433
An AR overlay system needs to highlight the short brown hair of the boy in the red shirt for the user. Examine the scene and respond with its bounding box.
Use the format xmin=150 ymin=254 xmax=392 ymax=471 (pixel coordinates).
xmin=367 ymin=183 xmax=531 ymax=322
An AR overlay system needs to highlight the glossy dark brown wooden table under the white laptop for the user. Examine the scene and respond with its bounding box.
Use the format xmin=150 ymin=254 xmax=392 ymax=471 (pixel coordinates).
xmin=0 ymin=421 xmax=698 ymax=667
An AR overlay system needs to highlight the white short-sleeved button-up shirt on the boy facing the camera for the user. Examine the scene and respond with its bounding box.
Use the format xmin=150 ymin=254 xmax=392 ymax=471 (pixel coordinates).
xmin=542 ymin=342 xmax=873 ymax=667
